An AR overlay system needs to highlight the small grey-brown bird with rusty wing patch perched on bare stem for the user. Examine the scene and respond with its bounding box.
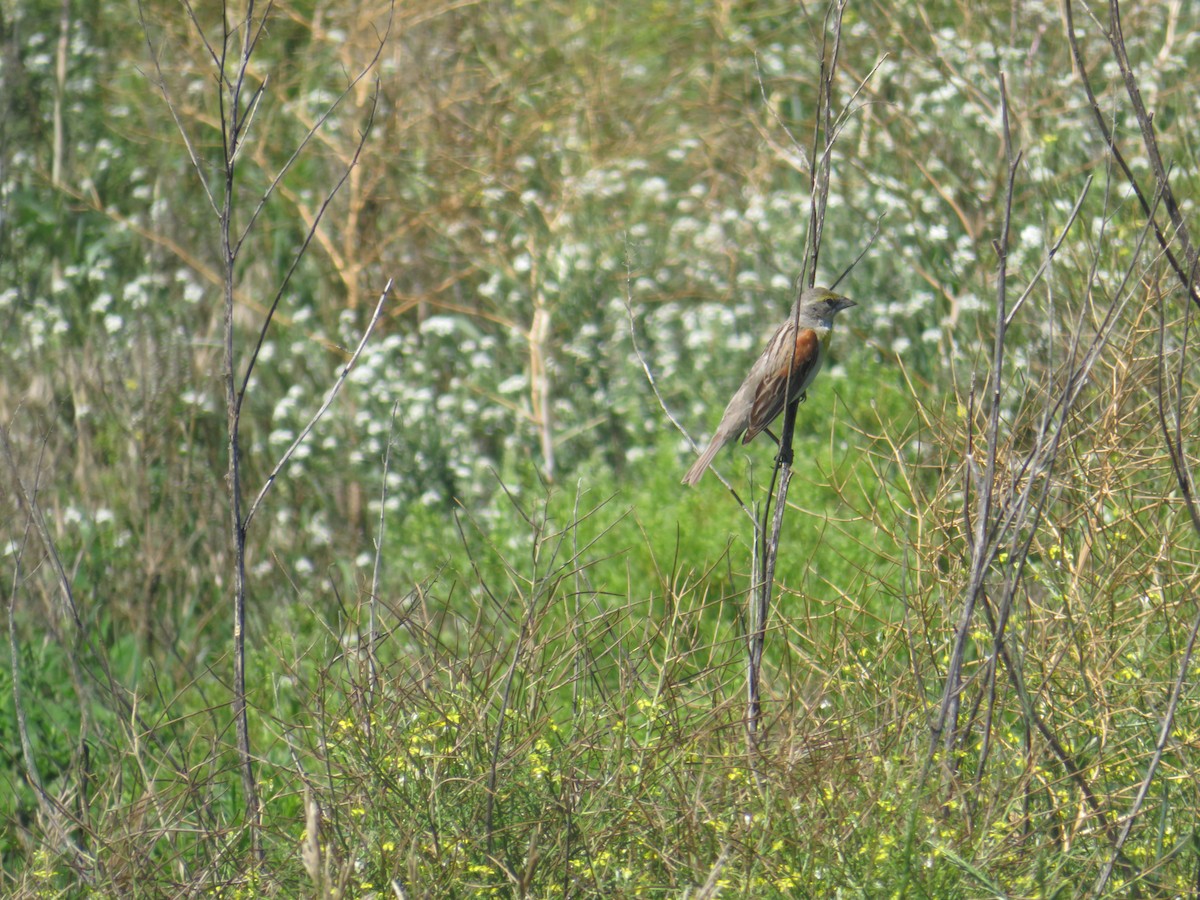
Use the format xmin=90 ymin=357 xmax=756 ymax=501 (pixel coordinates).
xmin=683 ymin=287 xmax=858 ymax=485
